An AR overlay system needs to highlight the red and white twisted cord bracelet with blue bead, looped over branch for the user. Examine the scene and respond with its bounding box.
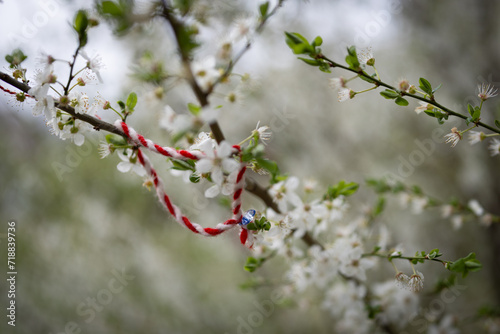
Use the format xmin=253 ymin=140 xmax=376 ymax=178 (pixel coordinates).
xmin=115 ymin=120 xmax=252 ymax=247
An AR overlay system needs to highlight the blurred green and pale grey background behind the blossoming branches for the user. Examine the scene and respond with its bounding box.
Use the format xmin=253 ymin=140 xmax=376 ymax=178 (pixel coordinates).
xmin=0 ymin=0 xmax=500 ymax=333
